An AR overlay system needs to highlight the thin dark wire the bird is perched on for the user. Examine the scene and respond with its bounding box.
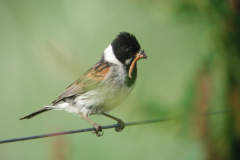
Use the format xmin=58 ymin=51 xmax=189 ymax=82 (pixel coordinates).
xmin=0 ymin=111 xmax=227 ymax=144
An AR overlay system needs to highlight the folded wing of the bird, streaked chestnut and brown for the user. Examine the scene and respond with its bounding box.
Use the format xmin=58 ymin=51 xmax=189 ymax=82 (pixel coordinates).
xmin=52 ymin=61 xmax=110 ymax=104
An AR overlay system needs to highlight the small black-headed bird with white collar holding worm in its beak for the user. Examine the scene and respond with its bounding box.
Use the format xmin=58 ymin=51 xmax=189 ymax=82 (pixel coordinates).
xmin=19 ymin=32 xmax=147 ymax=137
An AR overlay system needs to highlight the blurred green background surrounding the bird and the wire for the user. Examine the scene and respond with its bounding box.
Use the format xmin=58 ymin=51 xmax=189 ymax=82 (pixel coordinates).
xmin=0 ymin=0 xmax=240 ymax=160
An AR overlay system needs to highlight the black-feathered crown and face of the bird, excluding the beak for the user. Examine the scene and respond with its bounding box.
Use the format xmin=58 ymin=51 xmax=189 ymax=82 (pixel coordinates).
xmin=112 ymin=32 xmax=141 ymax=65
